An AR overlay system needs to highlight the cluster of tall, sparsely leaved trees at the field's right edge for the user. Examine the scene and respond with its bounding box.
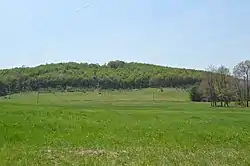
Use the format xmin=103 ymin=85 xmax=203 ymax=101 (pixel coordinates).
xmin=190 ymin=60 xmax=250 ymax=107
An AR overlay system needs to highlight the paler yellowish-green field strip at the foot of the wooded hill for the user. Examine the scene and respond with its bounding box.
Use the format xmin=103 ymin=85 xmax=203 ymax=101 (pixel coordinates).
xmin=0 ymin=88 xmax=189 ymax=104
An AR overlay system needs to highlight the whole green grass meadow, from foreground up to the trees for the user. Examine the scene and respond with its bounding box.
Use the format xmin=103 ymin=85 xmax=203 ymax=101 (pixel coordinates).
xmin=0 ymin=89 xmax=250 ymax=166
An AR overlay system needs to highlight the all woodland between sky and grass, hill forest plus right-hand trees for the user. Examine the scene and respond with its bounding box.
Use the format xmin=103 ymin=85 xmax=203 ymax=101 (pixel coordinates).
xmin=0 ymin=60 xmax=250 ymax=107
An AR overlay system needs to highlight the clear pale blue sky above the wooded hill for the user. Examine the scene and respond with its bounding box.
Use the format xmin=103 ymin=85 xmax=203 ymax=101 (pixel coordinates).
xmin=0 ymin=0 xmax=250 ymax=69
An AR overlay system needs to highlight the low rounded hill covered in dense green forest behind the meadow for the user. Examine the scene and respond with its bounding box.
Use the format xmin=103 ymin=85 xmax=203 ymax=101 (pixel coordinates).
xmin=0 ymin=61 xmax=202 ymax=93
